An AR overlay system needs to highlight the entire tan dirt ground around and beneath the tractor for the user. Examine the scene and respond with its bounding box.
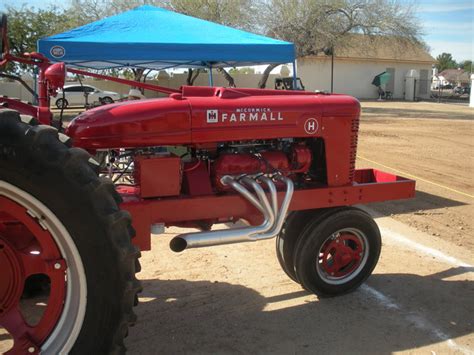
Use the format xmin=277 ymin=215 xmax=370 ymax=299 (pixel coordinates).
xmin=0 ymin=102 xmax=474 ymax=355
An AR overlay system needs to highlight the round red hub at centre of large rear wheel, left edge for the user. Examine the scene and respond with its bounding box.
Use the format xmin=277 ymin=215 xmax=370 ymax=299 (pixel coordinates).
xmin=0 ymin=235 xmax=24 ymax=314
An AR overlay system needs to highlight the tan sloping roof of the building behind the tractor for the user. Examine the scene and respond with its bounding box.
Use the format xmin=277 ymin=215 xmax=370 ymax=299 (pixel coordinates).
xmin=306 ymin=34 xmax=436 ymax=64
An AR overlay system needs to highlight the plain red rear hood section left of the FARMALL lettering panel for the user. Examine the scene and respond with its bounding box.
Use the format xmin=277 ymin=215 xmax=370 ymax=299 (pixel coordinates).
xmin=66 ymin=98 xmax=191 ymax=149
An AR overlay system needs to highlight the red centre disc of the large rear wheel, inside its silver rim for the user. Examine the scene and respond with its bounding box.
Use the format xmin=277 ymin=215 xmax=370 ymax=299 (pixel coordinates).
xmin=0 ymin=196 xmax=66 ymax=354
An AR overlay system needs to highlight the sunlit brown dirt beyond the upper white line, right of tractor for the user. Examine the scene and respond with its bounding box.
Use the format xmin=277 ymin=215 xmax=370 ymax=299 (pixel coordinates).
xmin=357 ymin=102 xmax=474 ymax=250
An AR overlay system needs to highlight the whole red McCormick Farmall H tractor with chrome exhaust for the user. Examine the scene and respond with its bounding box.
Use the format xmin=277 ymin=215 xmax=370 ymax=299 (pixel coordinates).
xmin=0 ymin=18 xmax=415 ymax=354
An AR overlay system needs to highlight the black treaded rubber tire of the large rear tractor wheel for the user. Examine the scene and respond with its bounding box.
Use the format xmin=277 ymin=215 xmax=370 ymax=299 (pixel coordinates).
xmin=0 ymin=110 xmax=141 ymax=354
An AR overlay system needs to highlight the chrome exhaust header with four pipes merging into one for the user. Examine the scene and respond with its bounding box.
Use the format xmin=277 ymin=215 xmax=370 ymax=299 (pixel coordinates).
xmin=170 ymin=174 xmax=294 ymax=252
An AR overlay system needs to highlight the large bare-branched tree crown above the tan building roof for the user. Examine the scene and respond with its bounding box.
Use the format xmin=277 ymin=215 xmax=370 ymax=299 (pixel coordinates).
xmin=259 ymin=0 xmax=422 ymax=88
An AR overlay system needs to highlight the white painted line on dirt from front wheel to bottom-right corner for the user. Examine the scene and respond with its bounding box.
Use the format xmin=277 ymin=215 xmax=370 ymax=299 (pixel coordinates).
xmin=360 ymin=284 xmax=474 ymax=355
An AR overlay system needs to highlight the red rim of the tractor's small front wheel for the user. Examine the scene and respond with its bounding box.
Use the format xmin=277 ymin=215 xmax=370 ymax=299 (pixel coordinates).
xmin=317 ymin=229 xmax=368 ymax=284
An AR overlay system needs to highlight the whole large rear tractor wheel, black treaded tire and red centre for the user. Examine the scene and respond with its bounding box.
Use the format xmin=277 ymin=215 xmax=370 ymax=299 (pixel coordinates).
xmin=0 ymin=110 xmax=140 ymax=354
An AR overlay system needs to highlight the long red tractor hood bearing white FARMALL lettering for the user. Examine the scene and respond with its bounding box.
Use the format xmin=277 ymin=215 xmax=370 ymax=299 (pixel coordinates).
xmin=66 ymin=86 xmax=360 ymax=150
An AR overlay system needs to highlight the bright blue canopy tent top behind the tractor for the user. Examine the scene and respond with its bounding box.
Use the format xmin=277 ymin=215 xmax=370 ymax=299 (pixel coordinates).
xmin=38 ymin=5 xmax=295 ymax=86
